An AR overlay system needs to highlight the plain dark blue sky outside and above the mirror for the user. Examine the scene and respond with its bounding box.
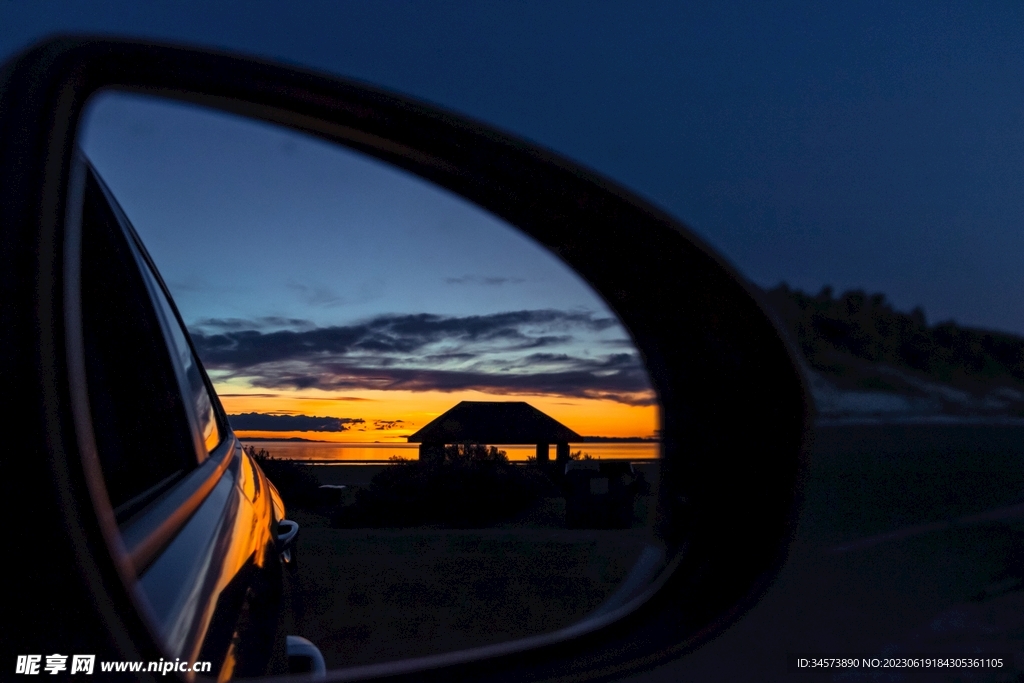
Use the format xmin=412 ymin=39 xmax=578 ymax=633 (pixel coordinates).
xmin=0 ymin=0 xmax=1024 ymax=333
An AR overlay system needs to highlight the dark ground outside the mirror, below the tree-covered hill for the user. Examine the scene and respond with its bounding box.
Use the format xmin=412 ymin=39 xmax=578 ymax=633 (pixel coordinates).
xmin=627 ymin=425 xmax=1024 ymax=683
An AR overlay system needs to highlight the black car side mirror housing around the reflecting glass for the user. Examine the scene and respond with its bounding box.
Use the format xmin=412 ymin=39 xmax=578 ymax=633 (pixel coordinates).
xmin=0 ymin=38 xmax=811 ymax=680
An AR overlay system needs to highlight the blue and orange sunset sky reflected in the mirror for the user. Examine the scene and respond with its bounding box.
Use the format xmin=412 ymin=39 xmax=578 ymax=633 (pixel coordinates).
xmin=81 ymin=94 xmax=657 ymax=442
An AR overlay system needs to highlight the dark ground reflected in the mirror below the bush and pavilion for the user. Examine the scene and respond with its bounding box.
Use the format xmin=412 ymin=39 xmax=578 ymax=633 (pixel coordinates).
xmin=276 ymin=463 xmax=657 ymax=668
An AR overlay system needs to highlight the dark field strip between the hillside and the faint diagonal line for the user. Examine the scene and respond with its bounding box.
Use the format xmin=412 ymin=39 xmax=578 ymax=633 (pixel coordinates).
xmin=802 ymin=425 xmax=1024 ymax=543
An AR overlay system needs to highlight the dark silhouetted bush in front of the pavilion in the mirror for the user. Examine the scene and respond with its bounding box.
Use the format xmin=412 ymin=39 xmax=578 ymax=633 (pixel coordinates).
xmin=333 ymin=444 xmax=557 ymax=527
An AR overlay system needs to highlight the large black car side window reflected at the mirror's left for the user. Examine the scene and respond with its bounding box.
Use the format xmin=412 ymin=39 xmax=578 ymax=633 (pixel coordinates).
xmin=82 ymin=163 xmax=197 ymax=520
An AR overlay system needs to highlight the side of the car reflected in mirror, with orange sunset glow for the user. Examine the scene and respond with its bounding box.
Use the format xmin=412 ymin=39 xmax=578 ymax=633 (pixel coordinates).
xmin=77 ymin=157 xmax=295 ymax=678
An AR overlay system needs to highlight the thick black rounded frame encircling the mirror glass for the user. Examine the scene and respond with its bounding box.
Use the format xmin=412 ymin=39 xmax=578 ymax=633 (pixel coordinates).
xmin=0 ymin=37 xmax=812 ymax=680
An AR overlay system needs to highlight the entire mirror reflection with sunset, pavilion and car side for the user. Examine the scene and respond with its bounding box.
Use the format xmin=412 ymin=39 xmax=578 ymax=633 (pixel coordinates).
xmin=79 ymin=92 xmax=665 ymax=675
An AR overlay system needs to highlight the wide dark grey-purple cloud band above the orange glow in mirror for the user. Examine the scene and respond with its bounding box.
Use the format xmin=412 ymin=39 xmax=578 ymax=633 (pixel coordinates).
xmin=193 ymin=309 xmax=654 ymax=404
